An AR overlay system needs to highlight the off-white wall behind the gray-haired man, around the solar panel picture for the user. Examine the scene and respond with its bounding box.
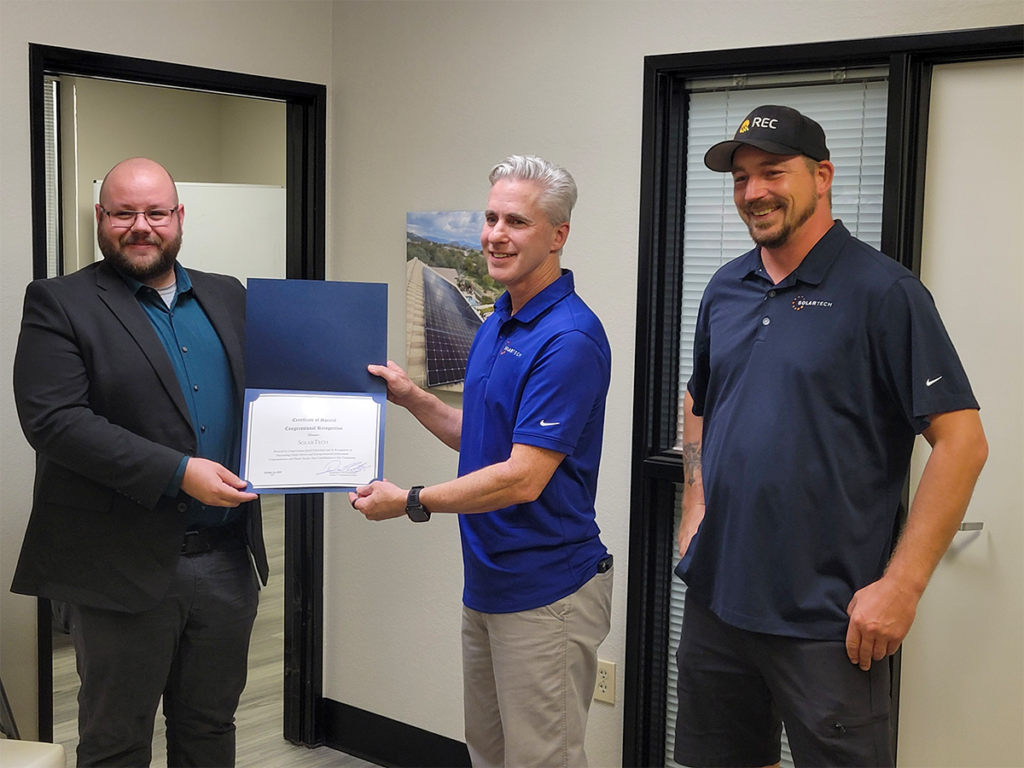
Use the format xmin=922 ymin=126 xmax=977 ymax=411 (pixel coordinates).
xmin=325 ymin=0 xmax=1024 ymax=768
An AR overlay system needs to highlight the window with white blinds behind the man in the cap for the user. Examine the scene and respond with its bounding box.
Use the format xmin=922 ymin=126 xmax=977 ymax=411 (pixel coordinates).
xmin=666 ymin=75 xmax=887 ymax=768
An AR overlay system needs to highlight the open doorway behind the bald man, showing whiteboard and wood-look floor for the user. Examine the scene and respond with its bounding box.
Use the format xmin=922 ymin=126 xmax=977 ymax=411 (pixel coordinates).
xmin=46 ymin=76 xmax=287 ymax=766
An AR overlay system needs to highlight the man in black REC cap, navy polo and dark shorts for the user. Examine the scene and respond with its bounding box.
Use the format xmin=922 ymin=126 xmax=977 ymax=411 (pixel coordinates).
xmin=675 ymin=105 xmax=987 ymax=768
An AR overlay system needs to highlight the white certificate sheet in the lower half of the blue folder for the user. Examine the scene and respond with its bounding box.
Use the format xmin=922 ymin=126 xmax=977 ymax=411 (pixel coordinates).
xmin=241 ymin=389 xmax=384 ymax=494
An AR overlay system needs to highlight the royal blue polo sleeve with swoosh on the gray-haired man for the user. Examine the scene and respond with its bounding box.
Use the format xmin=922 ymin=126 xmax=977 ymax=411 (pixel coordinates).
xmin=512 ymin=331 xmax=611 ymax=456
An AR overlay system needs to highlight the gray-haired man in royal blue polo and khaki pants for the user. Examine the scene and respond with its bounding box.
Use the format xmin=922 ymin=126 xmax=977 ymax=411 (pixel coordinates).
xmin=350 ymin=156 xmax=611 ymax=768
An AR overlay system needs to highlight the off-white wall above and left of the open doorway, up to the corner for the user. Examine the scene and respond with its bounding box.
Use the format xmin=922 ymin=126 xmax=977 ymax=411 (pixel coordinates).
xmin=0 ymin=0 xmax=333 ymax=735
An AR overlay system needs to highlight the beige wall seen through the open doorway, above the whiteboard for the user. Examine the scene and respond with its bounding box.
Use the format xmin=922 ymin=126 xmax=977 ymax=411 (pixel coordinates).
xmin=61 ymin=77 xmax=286 ymax=271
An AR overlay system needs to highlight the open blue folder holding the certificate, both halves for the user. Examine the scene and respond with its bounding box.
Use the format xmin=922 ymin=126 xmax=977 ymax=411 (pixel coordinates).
xmin=239 ymin=278 xmax=387 ymax=494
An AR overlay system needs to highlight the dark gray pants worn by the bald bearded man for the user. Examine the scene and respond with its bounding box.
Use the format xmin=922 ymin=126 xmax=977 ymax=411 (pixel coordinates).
xmin=69 ymin=547 xmax=258 ymax=768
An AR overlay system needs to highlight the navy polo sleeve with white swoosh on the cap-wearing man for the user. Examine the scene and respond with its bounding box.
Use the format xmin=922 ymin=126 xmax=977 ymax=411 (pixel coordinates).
xmin=878 ymin=276 xmax=978 ymax=434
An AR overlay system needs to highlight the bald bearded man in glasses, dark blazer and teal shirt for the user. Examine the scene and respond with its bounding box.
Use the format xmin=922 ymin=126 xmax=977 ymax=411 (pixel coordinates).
xmin=12 ymin=158 xmax=267 ymax=768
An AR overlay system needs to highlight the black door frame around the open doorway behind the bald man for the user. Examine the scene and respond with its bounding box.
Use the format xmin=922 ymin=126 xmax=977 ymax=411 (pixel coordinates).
xmin=29 ymin=43 xmax=327 ymax=746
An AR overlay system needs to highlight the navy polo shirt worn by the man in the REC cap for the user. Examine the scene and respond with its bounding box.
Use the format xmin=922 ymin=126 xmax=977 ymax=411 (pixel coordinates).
xmin=677 ymin=221 xmax=978 ymax=640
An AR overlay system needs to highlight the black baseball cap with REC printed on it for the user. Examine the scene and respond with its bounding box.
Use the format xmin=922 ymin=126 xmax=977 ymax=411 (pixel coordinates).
xmin=705 ymin=104 xmax=828 ymax=173
